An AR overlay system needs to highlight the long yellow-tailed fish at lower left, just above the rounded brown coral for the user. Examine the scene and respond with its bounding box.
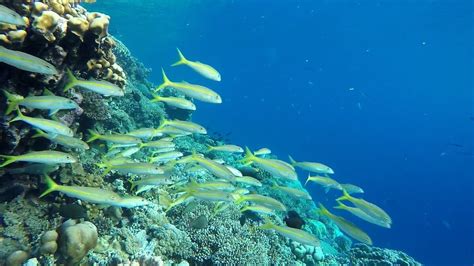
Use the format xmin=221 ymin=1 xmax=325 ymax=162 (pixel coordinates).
xmin=40 ymin=176 xmax=149 ymax=208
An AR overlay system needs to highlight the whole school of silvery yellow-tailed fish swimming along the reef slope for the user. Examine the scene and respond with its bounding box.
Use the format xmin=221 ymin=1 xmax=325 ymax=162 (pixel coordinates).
xmin=0 ymin=5 xmax=392 ymax=246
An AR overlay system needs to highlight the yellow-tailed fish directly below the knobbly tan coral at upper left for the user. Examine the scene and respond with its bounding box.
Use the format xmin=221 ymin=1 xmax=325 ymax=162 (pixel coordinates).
xmin=64 ymin=69 xmax=124 ymax=96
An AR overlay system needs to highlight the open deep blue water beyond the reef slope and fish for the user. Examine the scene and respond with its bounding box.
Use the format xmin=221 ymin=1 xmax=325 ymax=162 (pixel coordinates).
xmin=88 ymin=0 xmax=474 ymax=265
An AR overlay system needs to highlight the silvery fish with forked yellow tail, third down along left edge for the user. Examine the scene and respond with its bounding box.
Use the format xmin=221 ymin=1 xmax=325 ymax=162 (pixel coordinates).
xmin=3 ymin=90 xmax=79 ymax=115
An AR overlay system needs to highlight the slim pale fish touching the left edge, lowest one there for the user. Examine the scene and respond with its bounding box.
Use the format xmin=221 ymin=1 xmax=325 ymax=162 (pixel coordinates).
xmin=0 ymin=151 xmax=77 ymax=167
